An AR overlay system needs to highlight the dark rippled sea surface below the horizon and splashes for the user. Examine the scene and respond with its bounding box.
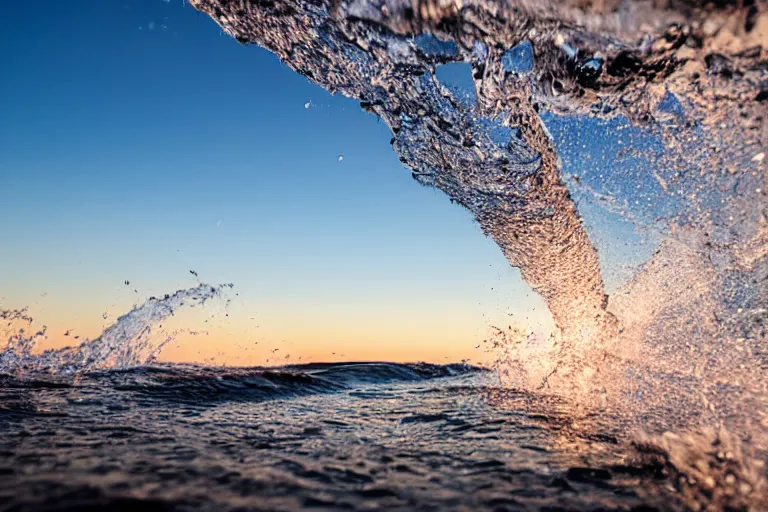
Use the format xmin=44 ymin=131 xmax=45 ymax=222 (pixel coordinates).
xmin=0 ymin=363 xmax=743 ymax=511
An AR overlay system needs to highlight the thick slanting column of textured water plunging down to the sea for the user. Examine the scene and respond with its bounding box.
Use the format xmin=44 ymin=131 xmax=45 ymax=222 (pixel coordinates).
xmin=193 ymin=1 xmax=613 ymax=344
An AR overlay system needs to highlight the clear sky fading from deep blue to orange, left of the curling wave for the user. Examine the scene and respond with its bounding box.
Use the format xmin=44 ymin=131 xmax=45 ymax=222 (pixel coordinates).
xmin=0 ymin=0 xmax=660 ymax=364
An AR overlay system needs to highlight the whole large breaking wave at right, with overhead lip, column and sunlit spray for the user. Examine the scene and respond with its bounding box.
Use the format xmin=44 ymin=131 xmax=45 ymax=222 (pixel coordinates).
xmin=191 ymin=0 xmax=768 ymax=442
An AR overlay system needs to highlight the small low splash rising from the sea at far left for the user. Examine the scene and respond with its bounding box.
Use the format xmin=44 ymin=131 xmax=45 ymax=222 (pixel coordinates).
xmin=0 ymin=284 xmax=232 ymax=375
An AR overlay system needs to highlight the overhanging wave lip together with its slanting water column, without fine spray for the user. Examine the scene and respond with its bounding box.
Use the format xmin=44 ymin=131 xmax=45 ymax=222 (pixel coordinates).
xmin=192 ymin=0 xmax=766 ymax=350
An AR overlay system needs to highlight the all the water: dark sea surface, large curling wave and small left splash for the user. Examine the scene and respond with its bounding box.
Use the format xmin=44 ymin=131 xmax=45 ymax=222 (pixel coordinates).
xmin=0 ymin=0 xmax=768 ymax=511
